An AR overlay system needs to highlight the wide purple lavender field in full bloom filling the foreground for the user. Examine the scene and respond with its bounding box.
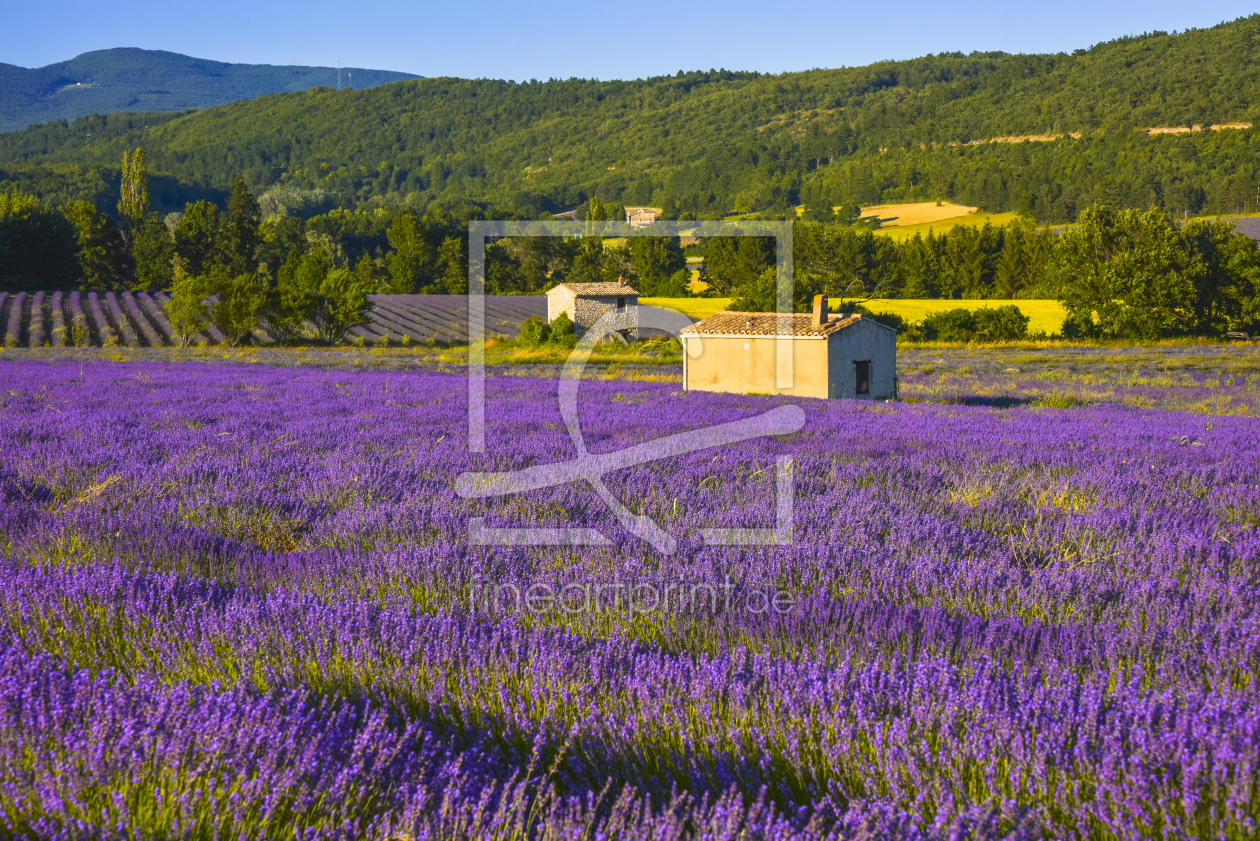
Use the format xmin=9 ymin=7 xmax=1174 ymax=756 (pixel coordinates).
xmin=0 ymin=357 xmax=1260 ymax=838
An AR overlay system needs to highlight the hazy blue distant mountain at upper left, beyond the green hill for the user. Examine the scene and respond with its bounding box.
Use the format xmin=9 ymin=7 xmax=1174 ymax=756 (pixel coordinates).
xmin=0 ymin=48 xmax=417 ymax=131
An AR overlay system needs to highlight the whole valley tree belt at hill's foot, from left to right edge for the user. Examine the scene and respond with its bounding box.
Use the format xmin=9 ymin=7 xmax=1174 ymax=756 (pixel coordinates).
xmin=0 ymin=149 xmax=1260 ymax=340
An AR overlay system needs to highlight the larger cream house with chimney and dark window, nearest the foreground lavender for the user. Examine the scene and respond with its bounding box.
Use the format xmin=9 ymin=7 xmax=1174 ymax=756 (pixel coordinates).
xmin=682 ymin=295 xmax=897 ymax=400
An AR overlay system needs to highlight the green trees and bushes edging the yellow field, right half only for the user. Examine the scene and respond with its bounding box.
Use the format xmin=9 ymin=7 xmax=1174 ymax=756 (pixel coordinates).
xmin=706 ymin=214 xmax=1260 ymax=340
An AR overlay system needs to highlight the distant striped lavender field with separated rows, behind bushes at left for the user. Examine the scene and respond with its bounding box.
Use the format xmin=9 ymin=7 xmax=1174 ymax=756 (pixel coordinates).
xmin=0 ymin=291 xmax=544 ymax=348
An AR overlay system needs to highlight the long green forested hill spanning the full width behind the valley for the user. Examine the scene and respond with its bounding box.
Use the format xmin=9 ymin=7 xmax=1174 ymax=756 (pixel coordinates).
xmin=0 ymin=15 xmax=1260 ymax=221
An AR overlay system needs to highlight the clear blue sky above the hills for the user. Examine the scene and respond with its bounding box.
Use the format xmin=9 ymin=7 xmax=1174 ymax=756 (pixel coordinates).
xmin=9 ymin=0 xmax=1256 ymax=81
